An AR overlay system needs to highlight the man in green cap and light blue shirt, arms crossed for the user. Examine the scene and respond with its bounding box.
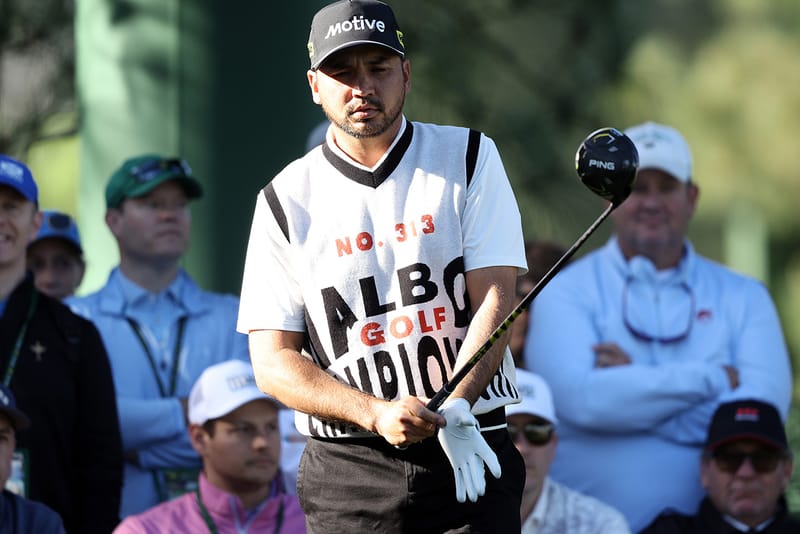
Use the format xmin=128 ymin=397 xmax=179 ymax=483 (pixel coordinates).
xmin=71 ymin=155 xmax=249 ymax=517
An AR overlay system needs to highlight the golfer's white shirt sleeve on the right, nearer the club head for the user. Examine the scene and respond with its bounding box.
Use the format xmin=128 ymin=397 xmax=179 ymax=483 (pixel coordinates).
xmin=462 ymin=134 xmax=527 ymax=274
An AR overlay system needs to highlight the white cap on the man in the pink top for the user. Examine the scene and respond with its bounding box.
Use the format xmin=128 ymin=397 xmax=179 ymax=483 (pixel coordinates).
xmin=189 ymin=360 xmax=281 ymax=425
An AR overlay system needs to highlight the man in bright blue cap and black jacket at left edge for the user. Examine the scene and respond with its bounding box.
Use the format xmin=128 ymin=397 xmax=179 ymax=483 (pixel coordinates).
xmin=0 ymin=155 xmax=122 ymax=534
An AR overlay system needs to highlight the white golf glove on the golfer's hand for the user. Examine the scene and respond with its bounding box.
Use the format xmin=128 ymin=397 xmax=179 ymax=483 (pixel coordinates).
xmin=437 ymin=398 xmax=501 ymax=502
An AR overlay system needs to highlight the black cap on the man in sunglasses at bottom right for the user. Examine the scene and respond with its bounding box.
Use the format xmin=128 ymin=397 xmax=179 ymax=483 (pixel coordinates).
xmin=705 ymin=399 xmax=789 ymax=452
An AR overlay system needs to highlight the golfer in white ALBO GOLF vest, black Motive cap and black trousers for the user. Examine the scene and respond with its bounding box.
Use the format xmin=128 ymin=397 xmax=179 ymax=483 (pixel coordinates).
xmin=238 ymin=1 xmax=525 ymax=533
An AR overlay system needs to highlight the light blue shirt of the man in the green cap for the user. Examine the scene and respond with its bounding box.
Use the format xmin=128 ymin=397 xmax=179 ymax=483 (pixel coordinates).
xmin=69 ymin=268 xmax=249 ymax=517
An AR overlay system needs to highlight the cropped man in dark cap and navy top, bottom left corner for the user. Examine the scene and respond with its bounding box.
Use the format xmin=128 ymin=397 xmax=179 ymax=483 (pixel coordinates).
xmin=0 ymin=384 xmax=65 ymax=534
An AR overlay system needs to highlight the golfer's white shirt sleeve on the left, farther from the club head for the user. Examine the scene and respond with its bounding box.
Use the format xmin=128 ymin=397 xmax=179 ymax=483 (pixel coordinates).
xmin=236 ymin=192 xmax=305 ymax=334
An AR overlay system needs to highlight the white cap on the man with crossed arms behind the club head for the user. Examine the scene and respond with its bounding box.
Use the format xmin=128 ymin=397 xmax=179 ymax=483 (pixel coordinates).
xmin=625 ymin=122 xmax=692 ymax=183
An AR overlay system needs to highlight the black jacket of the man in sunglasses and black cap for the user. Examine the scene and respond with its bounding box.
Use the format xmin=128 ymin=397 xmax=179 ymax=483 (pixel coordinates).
xmin=641 ymin=497 xmax=800 ymax=534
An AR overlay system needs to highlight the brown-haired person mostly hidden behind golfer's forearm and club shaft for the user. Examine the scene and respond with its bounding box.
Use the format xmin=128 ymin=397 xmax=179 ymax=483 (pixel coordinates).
xmin=508 ymin=240 xmax=567 ymax=367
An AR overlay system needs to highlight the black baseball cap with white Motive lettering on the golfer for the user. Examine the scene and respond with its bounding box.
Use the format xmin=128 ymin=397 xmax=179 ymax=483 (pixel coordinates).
xmin=308 ymin=0 xmax=406 ymax=70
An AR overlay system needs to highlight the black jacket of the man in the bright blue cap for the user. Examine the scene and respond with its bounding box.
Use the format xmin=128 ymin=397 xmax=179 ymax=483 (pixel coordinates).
xmin=0 ymin=275 xmax=123 ymax=534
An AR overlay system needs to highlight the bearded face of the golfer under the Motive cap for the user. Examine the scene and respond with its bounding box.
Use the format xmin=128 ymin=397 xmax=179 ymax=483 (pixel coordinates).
xmin=308 ymin=45 xmax=411 ymax=139
